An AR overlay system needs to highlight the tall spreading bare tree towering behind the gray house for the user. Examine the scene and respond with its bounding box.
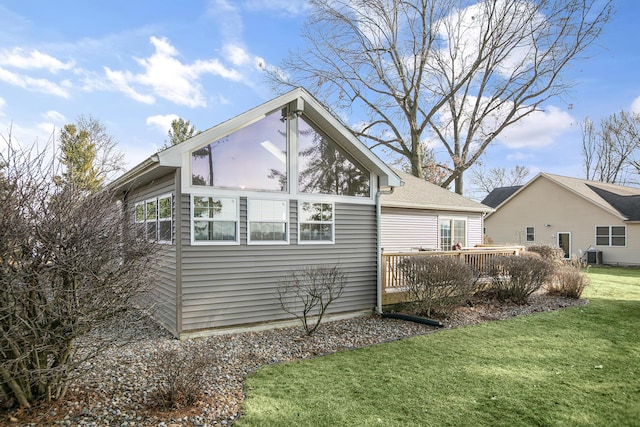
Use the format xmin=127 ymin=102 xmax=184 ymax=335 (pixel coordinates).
xmin=267 ymin=0 xmax=611 ymax=194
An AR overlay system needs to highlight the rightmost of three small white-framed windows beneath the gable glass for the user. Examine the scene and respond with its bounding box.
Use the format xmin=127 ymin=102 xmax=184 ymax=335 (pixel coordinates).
xmin=298 ymin=202 xmax=334 ymax=243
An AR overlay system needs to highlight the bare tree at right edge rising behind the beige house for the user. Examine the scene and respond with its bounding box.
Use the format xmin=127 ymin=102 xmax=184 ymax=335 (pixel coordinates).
xmin=581 ymin=110 xmax=640 ymax=185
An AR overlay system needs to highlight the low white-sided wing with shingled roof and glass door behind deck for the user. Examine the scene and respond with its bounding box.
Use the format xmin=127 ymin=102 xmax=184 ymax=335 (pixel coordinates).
xmin=380 ymin=171 xmax=493 ymax=253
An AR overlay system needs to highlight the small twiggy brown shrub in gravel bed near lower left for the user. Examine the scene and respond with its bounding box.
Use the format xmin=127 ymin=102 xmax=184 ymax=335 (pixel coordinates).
xmin=149 ymin=345 xmax=216 ymax=409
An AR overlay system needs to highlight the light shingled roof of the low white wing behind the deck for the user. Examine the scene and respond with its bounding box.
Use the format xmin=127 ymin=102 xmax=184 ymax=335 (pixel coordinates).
xmin=380 ymin=169 xmax=493 ymax=213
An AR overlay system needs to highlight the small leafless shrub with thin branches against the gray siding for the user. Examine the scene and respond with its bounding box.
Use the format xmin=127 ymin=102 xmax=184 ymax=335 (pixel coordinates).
xmin=277 ymin=265 xmax=347 ymax=335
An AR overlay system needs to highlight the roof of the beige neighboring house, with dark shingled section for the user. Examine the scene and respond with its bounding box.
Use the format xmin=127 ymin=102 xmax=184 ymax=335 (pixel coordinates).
xmin=483 ymin=172 xmax=640 ymax=222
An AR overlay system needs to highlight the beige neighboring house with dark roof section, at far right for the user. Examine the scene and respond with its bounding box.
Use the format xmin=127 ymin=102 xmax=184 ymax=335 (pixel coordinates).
xmin=482 ymin=173 xmax=640 ymax=265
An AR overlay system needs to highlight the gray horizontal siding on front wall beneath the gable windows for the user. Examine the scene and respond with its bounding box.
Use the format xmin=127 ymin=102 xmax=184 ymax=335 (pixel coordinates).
xmin=181 ymin=199 xmax=376 ymax=333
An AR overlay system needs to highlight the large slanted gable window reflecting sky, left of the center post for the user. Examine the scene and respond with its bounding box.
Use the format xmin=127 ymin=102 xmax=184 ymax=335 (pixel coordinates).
xmin=191 ymin=110 xmax=288 ymax=192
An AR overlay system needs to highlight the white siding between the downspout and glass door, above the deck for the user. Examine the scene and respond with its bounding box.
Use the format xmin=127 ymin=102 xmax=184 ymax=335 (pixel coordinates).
xmin=381 ymin=207 xmax=438 ymax=252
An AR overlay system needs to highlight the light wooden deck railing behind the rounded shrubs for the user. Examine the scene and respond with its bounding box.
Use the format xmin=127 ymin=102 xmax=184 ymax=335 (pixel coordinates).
xmin=382 ymin=246 xmax=524 ymax=304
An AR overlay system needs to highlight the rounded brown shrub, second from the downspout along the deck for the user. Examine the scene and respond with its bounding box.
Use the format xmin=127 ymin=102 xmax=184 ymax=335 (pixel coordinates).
xmin=488 ymin=256 xmax=554 ymax=304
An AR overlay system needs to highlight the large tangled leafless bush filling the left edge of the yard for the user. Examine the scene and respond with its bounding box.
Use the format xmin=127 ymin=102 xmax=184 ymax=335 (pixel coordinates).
xmin=0 ymin=136 xmax=152 ymax=408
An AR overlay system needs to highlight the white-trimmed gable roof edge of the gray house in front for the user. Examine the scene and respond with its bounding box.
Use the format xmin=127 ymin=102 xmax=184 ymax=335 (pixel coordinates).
xmin=109 ymin=88 xmax=402 ymax=192
